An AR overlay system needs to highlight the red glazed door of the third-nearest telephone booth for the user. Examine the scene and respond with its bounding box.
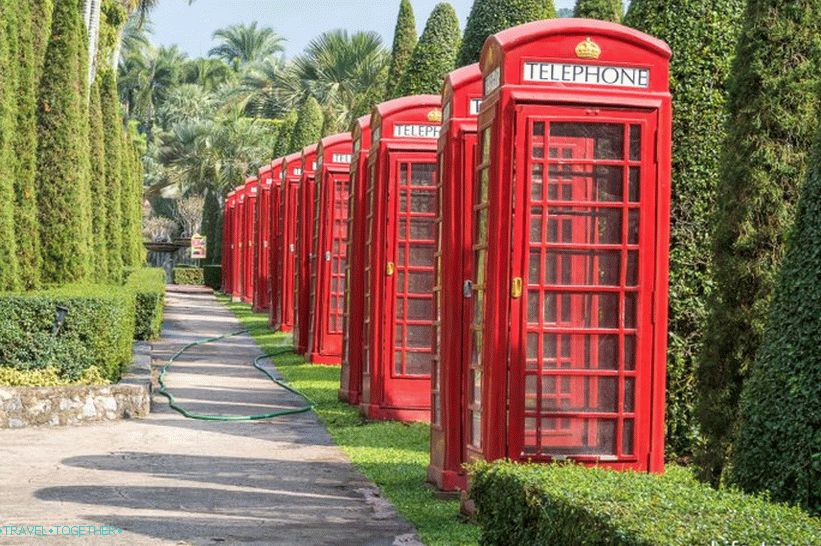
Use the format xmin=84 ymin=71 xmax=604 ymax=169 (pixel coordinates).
xmin=383 ymin=153 xmax=437 ymax=408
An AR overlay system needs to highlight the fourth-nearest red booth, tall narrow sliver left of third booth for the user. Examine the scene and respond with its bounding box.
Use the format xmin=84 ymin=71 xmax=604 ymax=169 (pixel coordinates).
xmin=339 ymin=115 xmax=371 ymax=405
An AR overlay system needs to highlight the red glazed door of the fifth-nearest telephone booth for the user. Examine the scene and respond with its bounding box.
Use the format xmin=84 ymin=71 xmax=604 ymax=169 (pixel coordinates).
xmin=311 ymin=171 xmax=351 ymax=364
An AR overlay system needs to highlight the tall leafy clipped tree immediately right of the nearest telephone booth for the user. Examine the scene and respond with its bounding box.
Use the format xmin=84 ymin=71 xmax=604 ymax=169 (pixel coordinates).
xmin=624 ymin=0 xmax=744 ymax=455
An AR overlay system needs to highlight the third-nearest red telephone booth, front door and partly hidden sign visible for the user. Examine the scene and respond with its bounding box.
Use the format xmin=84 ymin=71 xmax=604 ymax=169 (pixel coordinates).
xmin=361 ymin=95 xmax=442 ymax=421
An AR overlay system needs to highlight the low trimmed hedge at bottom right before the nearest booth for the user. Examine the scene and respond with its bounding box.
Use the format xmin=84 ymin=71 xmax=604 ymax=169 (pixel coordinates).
xmin=470 ymin=461 xmax=821 ymax=546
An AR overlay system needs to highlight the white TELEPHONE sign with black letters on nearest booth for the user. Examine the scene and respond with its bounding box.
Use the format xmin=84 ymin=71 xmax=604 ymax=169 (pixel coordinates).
xmin=523 ymin=62 xmax=650 ymax=87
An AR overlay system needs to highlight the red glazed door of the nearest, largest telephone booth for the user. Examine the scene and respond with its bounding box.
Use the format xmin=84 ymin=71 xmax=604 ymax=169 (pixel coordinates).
xmin=509 ymin=106 xmax=656 ymax=467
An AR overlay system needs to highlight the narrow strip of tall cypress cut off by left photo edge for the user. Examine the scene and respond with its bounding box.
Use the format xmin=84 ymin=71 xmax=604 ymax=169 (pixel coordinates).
xmin=0 ymin=0 xmax=20 ymax=291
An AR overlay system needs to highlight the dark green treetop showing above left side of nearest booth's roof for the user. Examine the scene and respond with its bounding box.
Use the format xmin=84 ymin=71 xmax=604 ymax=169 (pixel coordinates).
xmin=456 ymin=0 xmax=556 ymax=66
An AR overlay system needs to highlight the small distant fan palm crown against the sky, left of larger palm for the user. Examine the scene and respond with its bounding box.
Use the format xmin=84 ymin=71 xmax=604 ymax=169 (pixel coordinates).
xmin=208 ymin=21 xmax=285 ymax=72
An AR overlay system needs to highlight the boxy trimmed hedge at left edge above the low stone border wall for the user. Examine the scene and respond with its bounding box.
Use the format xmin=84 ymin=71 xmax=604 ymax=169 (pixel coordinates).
xmin=0 ymin=285 xmax=135 ymax=382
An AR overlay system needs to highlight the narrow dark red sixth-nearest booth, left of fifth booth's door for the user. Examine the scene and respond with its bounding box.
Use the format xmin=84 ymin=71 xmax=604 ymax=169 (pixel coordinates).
xmin=294 ymin=144 xmax=316 ymax=355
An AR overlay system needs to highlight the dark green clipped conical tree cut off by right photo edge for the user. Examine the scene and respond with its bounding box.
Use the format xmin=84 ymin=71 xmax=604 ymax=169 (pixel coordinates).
xmin=730 ymin=93 xmax=821 ymax=515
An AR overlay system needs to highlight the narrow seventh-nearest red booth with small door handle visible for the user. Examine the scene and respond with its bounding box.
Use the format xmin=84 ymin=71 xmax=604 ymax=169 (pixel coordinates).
xmin=274 ymin=152 xmax=302 ymax=332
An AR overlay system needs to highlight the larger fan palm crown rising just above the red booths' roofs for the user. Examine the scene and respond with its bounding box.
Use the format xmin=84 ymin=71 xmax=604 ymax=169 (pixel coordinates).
xmin=293 ymin=30 xmax=390 ymax=130
